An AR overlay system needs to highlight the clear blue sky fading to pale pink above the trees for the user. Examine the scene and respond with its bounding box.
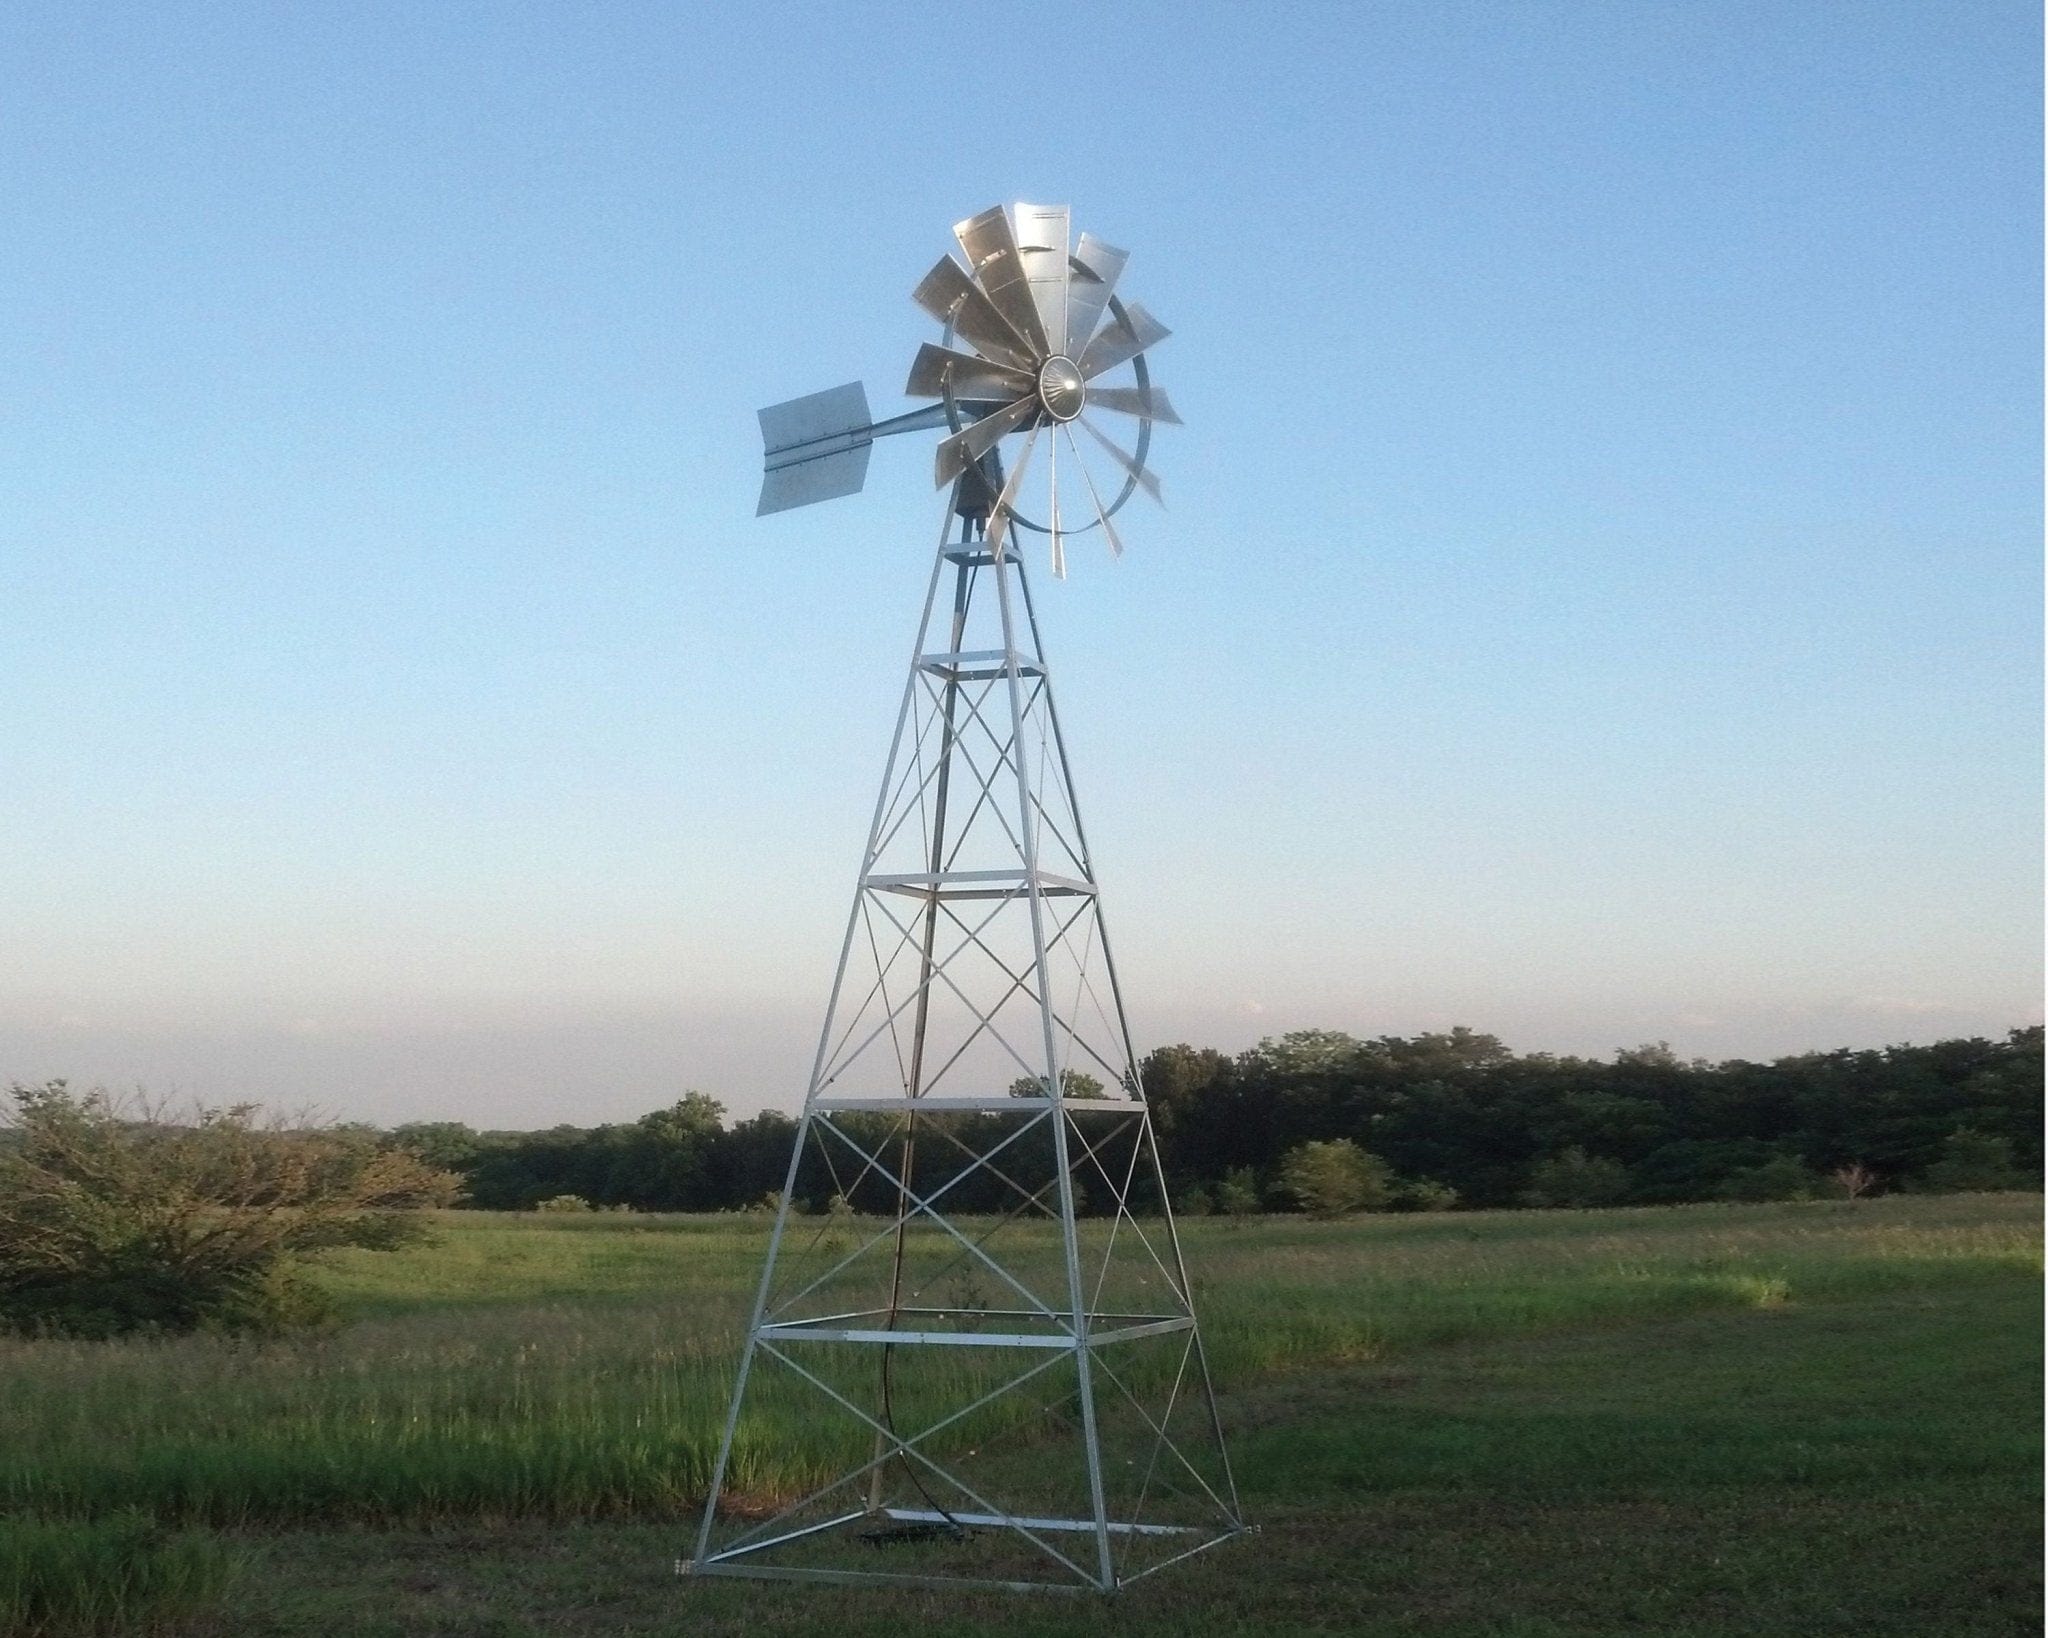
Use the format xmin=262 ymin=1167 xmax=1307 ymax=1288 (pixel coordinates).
xmin=0 ymin=0 xmax=2042 ymax=1126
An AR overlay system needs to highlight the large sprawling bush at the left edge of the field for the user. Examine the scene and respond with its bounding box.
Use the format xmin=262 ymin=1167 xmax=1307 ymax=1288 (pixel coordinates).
xmin=0 ymin=1081 xmax=461 ymax=1337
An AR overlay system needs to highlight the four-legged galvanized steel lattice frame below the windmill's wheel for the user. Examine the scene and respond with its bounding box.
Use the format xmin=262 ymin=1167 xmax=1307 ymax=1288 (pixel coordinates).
xmin=678 ymin=502 xmax=1245 ymax=1591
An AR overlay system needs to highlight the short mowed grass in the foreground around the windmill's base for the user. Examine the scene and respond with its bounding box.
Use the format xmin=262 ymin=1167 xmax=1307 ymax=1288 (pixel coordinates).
xmin=225 ymin=1276 xmax=2040 ymax=1638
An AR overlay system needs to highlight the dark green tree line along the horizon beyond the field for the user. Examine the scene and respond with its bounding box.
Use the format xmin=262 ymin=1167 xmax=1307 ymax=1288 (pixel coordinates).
xmin=381 ymin=1026 xmax=2042 ymax=1212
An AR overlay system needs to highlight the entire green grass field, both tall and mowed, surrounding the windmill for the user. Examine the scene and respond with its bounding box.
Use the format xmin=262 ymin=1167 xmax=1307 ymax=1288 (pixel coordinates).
xmin=0 ymin=1196 xmax=2040 ymax=1638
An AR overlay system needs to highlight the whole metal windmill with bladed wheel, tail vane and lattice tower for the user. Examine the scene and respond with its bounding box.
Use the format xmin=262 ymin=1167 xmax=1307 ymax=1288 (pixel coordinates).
xmin=688 ymin=205 xmax=1243 ymax=1591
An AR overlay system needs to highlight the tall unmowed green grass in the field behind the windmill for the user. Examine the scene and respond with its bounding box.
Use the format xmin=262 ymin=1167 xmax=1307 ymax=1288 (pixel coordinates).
xmin=0 ymin=1196 xmax=2040 ymax=1523
